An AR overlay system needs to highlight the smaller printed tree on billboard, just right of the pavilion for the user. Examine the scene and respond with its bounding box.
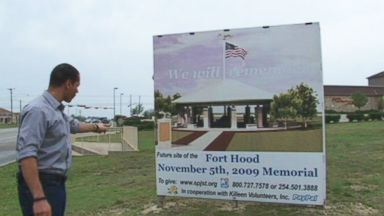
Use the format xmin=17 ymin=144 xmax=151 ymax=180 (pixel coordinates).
xmin=271 ymin=93 xmax=297 ymax=129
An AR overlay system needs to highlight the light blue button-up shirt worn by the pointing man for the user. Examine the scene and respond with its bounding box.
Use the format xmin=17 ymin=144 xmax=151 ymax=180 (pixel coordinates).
xmin=16 ymin=91 xmax=80 ymax=175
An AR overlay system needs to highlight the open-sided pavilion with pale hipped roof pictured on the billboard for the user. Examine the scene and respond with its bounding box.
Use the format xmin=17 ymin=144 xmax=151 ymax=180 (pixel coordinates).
xmin=173 ymin=80 xmax=273 ymax=128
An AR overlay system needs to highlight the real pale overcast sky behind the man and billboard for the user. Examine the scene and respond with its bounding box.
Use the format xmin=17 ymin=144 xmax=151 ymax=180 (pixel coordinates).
xmin=0 ymin=0 xmax=384 ymax=118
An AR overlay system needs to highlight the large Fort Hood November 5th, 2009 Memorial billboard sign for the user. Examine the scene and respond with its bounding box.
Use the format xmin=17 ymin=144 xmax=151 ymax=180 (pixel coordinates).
xmin=153 ymin=23 xmax=326 ymax=205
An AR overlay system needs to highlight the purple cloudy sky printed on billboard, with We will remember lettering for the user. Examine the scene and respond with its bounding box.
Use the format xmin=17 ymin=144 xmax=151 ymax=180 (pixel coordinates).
xmin=154 ymin=24 xmax=323 ymax=101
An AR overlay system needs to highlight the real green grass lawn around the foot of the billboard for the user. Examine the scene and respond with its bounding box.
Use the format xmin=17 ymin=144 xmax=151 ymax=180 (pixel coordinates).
xmin=0 ymin=121 xmax=384 ymax=216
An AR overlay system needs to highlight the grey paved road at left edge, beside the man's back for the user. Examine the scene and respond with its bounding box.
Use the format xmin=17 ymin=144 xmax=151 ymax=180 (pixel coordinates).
xmin=0 ymin=128 xmax=17 ymax=166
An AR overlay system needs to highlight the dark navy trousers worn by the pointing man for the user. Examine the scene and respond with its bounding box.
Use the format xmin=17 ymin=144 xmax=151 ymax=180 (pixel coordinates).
xmin=17 ymin=172 xmax=66 ymax=216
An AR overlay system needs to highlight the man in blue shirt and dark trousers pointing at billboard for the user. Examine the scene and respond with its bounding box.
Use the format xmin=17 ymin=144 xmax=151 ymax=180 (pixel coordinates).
xmin=16 ymin=63 xmax=107 ymax=216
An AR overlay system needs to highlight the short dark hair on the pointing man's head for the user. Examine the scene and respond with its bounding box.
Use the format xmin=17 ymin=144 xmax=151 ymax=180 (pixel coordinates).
xmin=49 ymin=63 xmax=80 ymax=87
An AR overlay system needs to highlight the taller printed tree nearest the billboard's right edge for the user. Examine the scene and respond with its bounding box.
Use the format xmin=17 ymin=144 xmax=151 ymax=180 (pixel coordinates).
xmin=288 ymin=83 xmax=319 ymax=128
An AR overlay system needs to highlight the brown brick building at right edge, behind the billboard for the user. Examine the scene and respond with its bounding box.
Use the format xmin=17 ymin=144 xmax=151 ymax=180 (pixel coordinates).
xmin=324 ymin=71 xmax=384 ymax=112
